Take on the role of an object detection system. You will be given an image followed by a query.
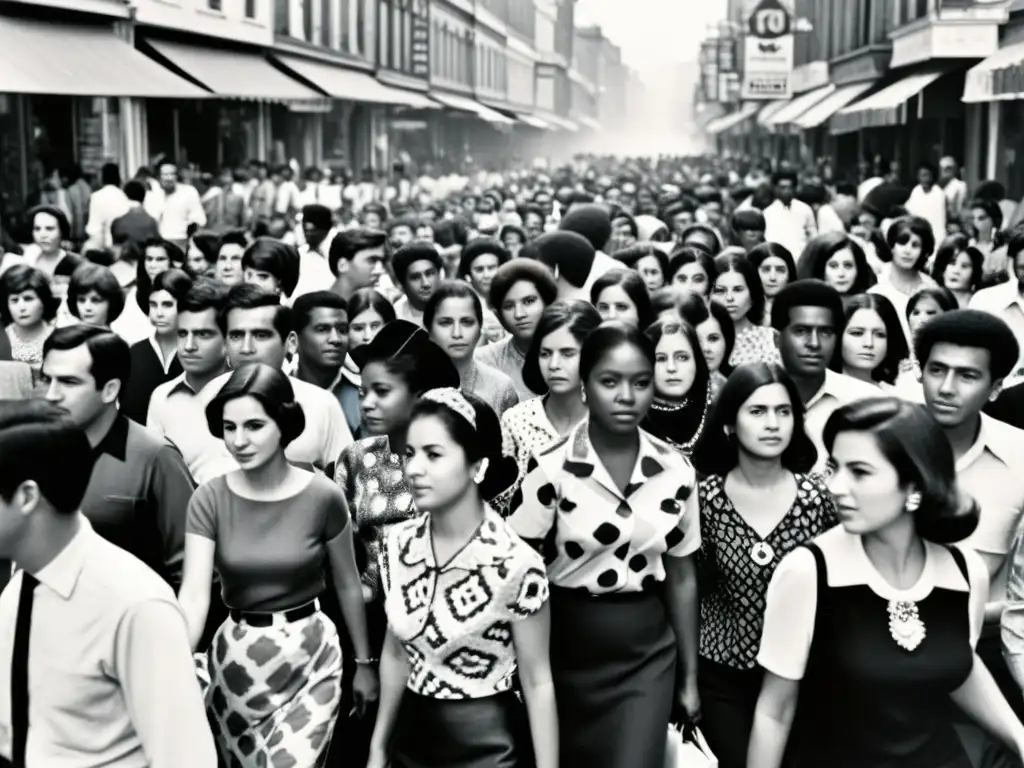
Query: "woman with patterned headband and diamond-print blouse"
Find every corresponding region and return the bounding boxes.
[368,391,558,768]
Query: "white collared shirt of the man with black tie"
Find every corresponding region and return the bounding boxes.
[0,515,217,768]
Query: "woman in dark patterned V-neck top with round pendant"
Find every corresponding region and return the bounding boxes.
[693,362,838,768]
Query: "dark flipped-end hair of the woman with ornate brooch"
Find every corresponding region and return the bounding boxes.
[823,397,979,544]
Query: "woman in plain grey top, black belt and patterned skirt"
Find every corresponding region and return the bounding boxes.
[178,364,379,766]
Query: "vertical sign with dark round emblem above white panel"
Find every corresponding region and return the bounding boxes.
[742,0,794,101]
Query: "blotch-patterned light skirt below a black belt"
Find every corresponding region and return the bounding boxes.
[196,611,341,768]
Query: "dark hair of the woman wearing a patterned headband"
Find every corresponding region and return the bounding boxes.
[409,392,514,502]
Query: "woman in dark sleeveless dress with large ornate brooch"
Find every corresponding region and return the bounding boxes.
[750,397,1024,768]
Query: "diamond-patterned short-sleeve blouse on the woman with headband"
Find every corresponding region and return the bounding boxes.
[380,509,548,699]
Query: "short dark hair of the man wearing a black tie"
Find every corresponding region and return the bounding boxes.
[0,399,93,515]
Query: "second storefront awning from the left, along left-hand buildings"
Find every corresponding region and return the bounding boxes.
[145,38,324,102]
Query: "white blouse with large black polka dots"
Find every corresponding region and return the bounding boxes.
[509,421,700,594]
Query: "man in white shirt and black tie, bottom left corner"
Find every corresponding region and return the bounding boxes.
[0,400,217,768]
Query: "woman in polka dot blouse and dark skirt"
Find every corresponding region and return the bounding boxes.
[509,322,700,768]
